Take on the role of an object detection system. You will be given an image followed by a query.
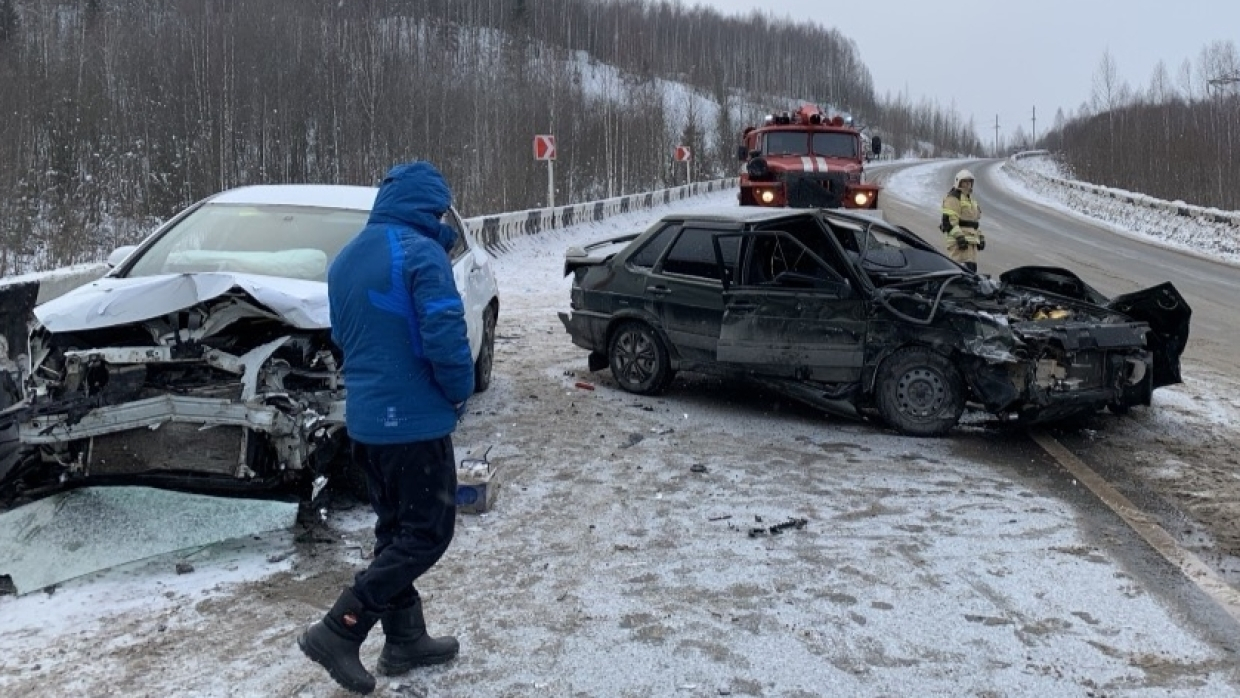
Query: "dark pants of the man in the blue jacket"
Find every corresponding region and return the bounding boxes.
[353,436,456,611]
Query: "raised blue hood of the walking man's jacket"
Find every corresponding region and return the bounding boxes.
[367,160,456,252]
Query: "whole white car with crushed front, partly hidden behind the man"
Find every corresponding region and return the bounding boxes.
[0,185,500,500]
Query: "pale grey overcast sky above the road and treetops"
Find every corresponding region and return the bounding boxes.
[684,0,1240,145]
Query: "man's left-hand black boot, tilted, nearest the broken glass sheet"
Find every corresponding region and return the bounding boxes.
[298,589,379,693]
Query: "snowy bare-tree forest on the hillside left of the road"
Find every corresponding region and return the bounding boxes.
[0,0,981,275]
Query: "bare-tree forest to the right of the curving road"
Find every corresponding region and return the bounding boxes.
[1040,41,1240,211]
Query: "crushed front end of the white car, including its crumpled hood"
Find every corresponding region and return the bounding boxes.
[5,273,347,497]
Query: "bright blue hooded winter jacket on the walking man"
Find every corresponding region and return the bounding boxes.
[327,161,474,444]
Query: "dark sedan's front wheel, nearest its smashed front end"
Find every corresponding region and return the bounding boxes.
[878,347,965,436]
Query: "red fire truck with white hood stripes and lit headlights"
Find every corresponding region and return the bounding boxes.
[737,104,883,212]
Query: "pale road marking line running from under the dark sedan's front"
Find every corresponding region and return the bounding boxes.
[1029,431,1240,622]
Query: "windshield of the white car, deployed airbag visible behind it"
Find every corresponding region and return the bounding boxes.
[125,203,370,281]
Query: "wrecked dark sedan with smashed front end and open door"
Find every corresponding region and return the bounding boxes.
[559,207,1190,436]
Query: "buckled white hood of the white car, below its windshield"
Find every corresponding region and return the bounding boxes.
[35,272,331,332]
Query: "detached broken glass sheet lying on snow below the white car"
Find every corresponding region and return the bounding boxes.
[0,487,298,594]
